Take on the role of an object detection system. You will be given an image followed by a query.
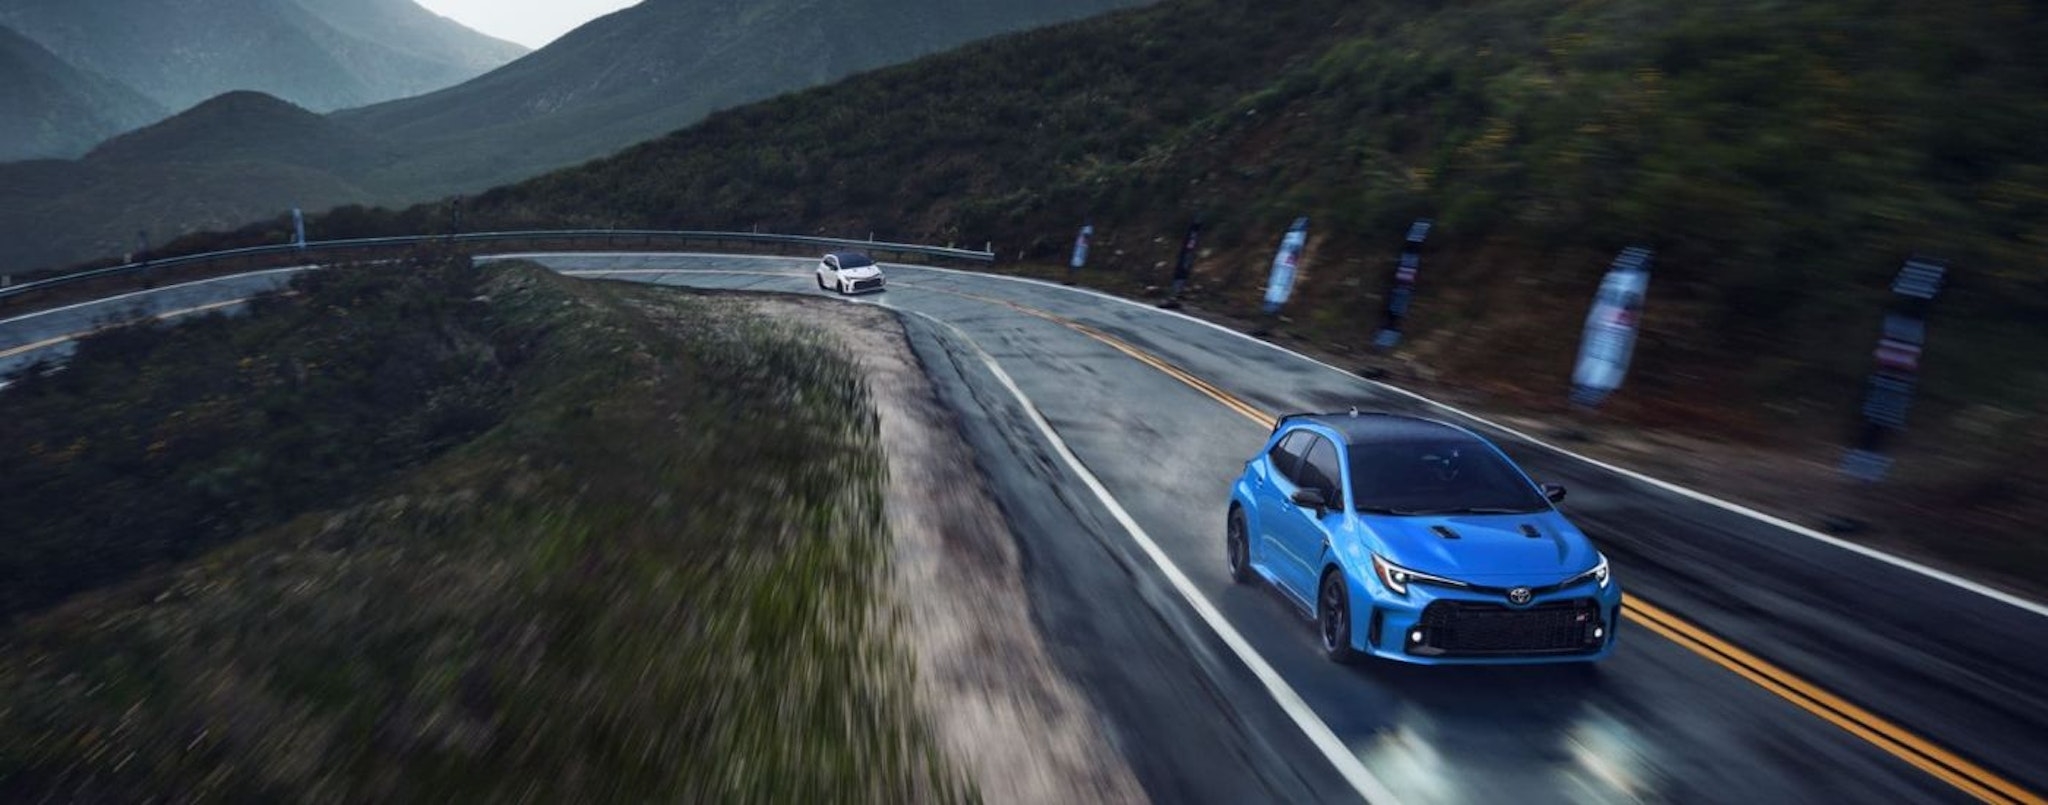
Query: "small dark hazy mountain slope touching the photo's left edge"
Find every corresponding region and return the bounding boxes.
[0,27,164,162]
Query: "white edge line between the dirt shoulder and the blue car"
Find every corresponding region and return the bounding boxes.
[893,307,1401,805]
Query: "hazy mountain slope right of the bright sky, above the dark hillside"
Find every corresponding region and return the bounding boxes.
[336,0,1147,193]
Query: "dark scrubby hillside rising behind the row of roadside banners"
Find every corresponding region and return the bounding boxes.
[448,0,2048,438]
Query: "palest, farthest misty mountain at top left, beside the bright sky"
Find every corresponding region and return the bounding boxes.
[0,0,524,111]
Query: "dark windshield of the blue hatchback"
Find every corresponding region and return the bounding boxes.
[1350,438,1550,514]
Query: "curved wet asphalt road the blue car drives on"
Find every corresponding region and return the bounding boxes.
[0,254,2048,805]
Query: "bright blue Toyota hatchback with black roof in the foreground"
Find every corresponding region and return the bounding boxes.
[1227,412,1622,664]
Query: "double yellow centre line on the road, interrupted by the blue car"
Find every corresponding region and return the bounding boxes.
[966,291,2048,805]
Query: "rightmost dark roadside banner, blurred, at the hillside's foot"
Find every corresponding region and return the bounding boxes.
[1841,256,1948,483]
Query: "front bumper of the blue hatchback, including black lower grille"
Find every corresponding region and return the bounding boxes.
[1352,580,1622,666]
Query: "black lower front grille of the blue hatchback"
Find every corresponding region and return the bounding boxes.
[1407,598,1606,658]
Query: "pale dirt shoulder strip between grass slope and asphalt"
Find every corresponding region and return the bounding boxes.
[752,299,1147,803]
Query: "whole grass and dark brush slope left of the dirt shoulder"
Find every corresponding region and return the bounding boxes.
[0,260,958,803]
